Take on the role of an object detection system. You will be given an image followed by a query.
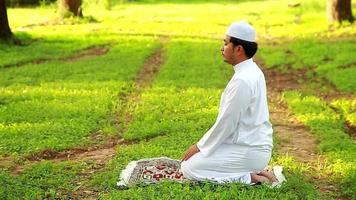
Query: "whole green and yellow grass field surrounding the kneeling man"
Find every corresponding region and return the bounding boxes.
[0,0,356,199]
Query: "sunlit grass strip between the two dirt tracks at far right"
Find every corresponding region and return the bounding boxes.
[283,92,356,199]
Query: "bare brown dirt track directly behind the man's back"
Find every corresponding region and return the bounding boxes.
[256,58,341,199]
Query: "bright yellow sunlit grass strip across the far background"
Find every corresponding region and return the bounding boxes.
[11,0,356,41]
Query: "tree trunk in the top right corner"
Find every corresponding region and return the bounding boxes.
[327,0,355,23]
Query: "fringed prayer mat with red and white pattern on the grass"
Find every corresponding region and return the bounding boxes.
[117,157,186,187]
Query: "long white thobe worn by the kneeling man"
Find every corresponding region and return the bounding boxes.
[181,59,273,184]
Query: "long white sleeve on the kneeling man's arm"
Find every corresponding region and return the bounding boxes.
[197,80,252,157]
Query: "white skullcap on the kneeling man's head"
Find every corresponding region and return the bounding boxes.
[226,21,256,42]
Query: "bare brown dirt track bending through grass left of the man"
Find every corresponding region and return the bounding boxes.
[12,37,168,175]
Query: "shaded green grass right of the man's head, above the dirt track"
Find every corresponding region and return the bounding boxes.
[259,38,356,93]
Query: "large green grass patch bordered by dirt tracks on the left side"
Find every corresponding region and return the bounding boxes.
[0,38,158,157]
